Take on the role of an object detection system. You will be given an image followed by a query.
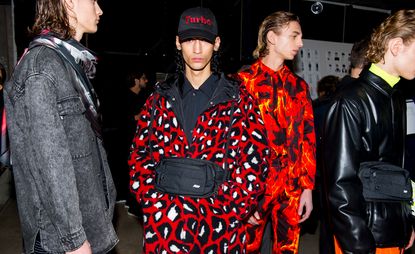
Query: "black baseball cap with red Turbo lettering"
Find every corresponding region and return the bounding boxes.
[177,7,218,44]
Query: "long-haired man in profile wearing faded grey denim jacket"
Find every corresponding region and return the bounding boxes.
[4,0,118,253]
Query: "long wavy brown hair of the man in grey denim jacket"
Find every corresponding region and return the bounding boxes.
[30,0,75,40]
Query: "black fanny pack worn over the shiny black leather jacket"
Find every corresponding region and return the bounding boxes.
[359,161,412,201]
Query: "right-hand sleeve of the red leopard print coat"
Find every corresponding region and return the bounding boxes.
[214,89,269,220]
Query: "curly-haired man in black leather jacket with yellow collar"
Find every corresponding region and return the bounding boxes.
[323,10,415,254]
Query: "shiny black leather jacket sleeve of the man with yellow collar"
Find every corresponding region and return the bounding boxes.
[323,98,375,253]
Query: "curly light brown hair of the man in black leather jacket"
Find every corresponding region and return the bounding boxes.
[366,10,415,63]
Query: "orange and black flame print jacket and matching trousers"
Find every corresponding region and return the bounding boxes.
[238,60,316,253]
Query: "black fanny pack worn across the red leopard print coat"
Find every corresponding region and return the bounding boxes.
[155,158,229,198]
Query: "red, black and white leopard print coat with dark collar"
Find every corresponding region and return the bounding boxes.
[129,75,269,253]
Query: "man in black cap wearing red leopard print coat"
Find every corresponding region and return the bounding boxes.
[129,7,268,253]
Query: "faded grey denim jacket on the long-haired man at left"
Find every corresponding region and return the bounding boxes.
[4,46,118,253]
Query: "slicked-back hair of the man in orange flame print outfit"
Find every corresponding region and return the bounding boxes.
[252,11,300,58]
